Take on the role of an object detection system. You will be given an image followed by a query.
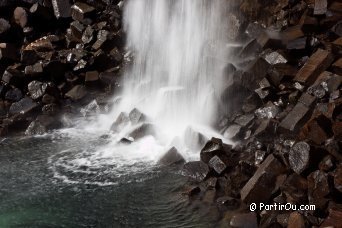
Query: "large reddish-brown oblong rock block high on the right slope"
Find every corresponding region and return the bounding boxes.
[294,49,333,85]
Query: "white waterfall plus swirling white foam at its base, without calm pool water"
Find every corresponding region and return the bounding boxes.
[50,0,229,183]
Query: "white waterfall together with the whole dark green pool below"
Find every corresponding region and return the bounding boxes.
[0,0,229,227]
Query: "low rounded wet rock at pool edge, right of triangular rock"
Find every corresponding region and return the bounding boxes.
[183,161,209,182]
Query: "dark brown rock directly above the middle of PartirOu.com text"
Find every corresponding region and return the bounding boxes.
[280,173,308,204]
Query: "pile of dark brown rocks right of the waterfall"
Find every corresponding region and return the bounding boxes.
[184,0,342,227]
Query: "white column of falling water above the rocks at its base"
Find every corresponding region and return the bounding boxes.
[119,0,228,150]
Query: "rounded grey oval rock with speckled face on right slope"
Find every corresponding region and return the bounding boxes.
[289,142,310,174]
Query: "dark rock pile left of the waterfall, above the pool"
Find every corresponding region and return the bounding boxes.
[0,0,124,136]
